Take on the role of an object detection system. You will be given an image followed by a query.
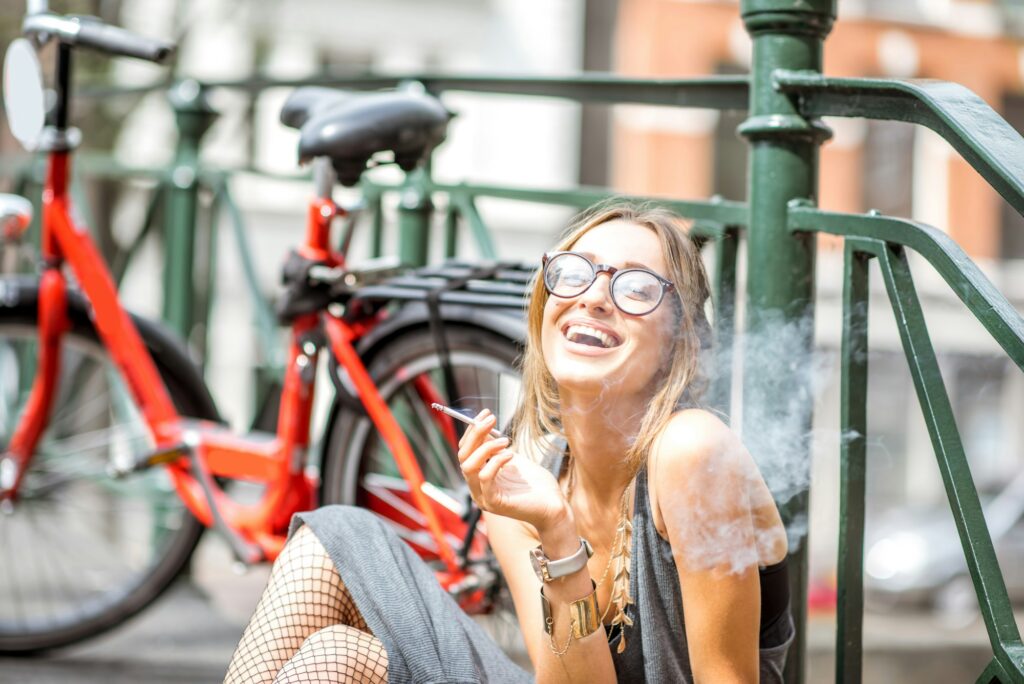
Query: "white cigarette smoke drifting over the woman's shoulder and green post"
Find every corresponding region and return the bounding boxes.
[663,311,843,572]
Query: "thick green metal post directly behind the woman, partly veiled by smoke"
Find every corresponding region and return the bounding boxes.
[739,0,837,682]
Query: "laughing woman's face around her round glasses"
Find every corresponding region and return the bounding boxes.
[541,220,675,397]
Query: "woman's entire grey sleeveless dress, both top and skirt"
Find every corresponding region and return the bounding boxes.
[292,448,795,684]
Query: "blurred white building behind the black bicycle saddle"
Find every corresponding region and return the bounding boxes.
[102,0,585,426]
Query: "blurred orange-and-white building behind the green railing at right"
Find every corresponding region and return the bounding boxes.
[609,0,1024,597]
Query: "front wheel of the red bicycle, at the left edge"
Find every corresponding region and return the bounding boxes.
[0,283,216,653]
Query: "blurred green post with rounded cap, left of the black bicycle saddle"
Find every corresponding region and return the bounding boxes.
[164,80,214,340]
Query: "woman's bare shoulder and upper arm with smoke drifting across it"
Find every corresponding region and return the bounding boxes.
[651,411,785,682]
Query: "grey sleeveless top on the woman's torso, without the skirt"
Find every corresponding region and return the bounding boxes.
[545,452,795,684]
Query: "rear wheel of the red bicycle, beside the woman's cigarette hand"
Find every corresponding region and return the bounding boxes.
[324,325,529,667]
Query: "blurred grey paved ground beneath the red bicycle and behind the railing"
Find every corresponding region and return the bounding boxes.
[0,536,1024,684]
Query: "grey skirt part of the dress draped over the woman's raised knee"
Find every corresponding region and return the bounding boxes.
[291,506,532,684]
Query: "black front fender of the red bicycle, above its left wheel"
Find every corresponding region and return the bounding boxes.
[0,276,221,422]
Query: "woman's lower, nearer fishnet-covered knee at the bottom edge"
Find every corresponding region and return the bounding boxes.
[273,625,387,684]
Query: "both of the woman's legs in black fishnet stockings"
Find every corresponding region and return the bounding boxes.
[224,526,387,684]
